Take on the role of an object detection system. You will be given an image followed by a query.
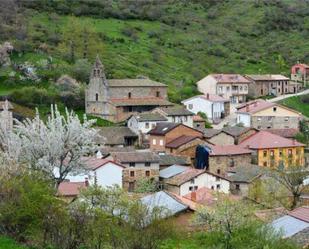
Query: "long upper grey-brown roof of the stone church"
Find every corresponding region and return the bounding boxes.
[107,78,167,87]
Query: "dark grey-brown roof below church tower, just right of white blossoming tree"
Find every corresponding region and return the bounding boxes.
[97,126,138,145]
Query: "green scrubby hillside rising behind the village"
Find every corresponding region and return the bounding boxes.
[0,0,309,101]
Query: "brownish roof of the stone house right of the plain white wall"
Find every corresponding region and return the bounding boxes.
[112,151,160,163]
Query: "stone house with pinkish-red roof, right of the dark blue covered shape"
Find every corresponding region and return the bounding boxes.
[208,145,252,175]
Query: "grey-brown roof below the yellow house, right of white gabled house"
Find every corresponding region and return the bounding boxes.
[226,164,264,183]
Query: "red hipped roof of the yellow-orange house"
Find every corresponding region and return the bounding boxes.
[239,131,305,149]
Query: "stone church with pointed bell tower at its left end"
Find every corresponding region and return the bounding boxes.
[85,58,172,122]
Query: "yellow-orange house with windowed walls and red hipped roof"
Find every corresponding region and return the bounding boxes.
[240,131,305,168]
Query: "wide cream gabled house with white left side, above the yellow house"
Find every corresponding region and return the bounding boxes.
[236,99,302,130]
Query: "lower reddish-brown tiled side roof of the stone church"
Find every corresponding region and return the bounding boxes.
[110,97,173,106]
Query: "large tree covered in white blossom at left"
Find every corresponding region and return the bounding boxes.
[0,106,97,186]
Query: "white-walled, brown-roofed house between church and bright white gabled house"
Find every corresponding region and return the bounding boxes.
[152,106,194,127]
